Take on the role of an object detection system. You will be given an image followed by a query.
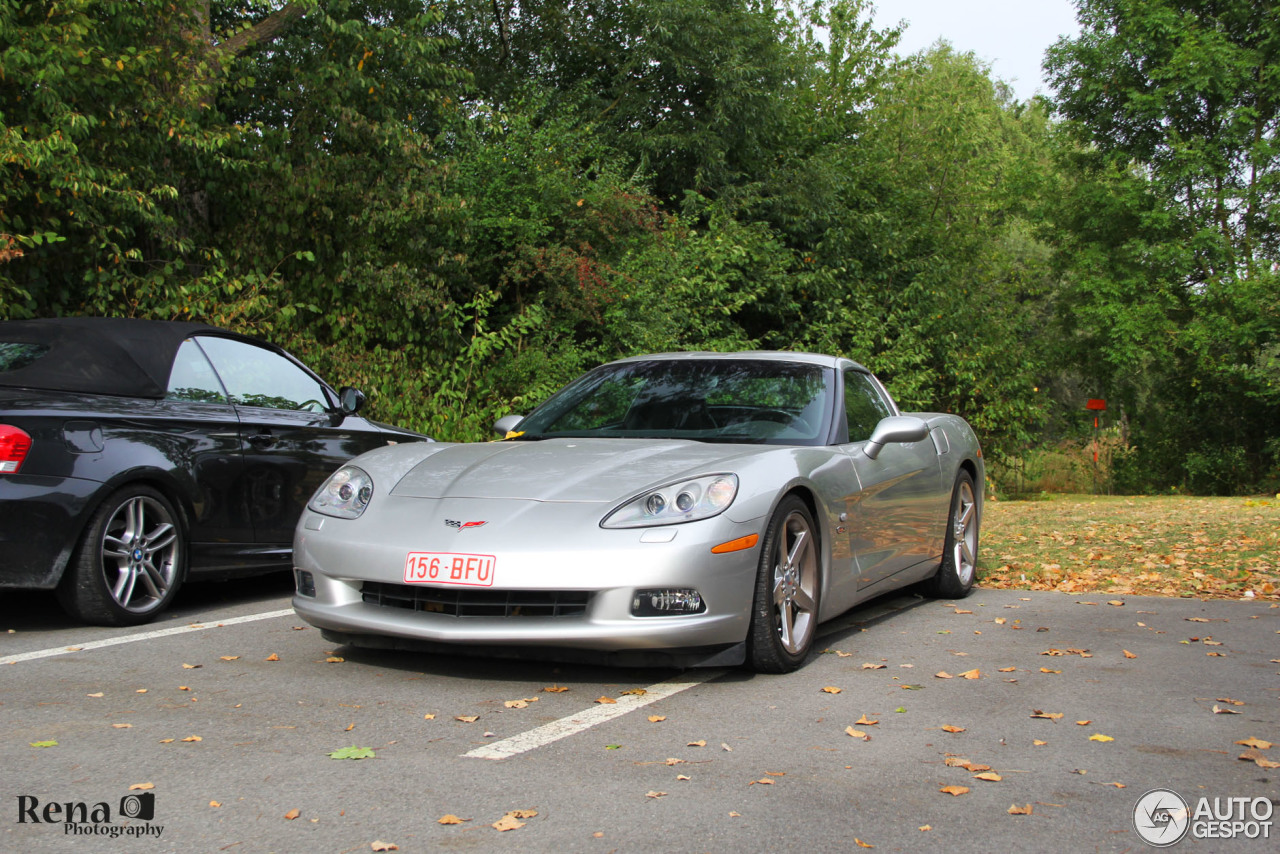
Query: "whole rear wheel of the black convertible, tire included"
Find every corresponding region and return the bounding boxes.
[58,485,187,626]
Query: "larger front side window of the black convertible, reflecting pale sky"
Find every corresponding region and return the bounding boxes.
[200,335,329,412]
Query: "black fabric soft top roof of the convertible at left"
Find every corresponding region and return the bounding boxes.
[0,318,264,399]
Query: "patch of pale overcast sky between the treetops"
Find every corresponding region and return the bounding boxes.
[874,0,1079,101]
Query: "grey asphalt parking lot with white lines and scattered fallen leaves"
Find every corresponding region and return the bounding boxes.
[0,580,1280,854]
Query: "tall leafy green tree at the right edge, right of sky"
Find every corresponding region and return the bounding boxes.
[1046,0,1280,492]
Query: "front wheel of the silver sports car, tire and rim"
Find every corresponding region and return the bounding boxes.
[746,495,822,673]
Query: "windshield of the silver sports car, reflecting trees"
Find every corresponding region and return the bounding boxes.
[518,359,835,446]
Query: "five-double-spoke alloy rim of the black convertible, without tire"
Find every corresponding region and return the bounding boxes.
[101,495,179,613]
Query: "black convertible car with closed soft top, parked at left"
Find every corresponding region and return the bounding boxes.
[0,318,426,626]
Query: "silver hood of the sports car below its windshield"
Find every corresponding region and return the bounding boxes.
[392,439,765,502]
